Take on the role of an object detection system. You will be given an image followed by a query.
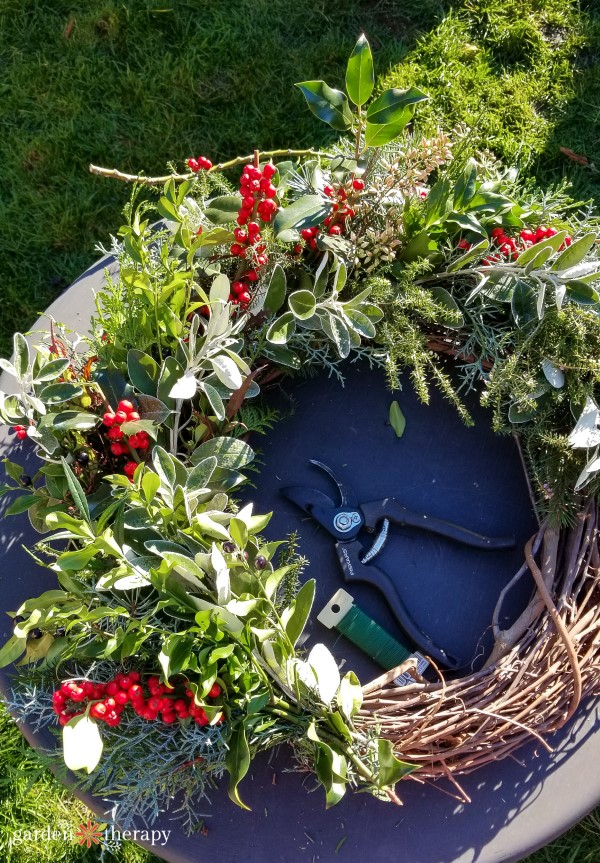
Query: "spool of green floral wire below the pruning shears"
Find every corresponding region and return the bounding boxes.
[317,589,429,684]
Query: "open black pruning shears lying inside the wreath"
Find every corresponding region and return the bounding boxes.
[280,459,515,669]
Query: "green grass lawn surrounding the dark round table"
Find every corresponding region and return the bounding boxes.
[0,0,600,863]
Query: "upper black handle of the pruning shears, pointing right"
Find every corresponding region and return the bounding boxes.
[361,497,515,551]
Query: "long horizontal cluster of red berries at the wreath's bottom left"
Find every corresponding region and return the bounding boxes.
[52,671,225,727]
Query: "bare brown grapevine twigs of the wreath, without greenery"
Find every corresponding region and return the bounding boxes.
[359,503,600,799]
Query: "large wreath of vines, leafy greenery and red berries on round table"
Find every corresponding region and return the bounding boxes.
[0,37,600,823]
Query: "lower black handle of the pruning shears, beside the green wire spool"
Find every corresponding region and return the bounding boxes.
[335,541,464,670]
